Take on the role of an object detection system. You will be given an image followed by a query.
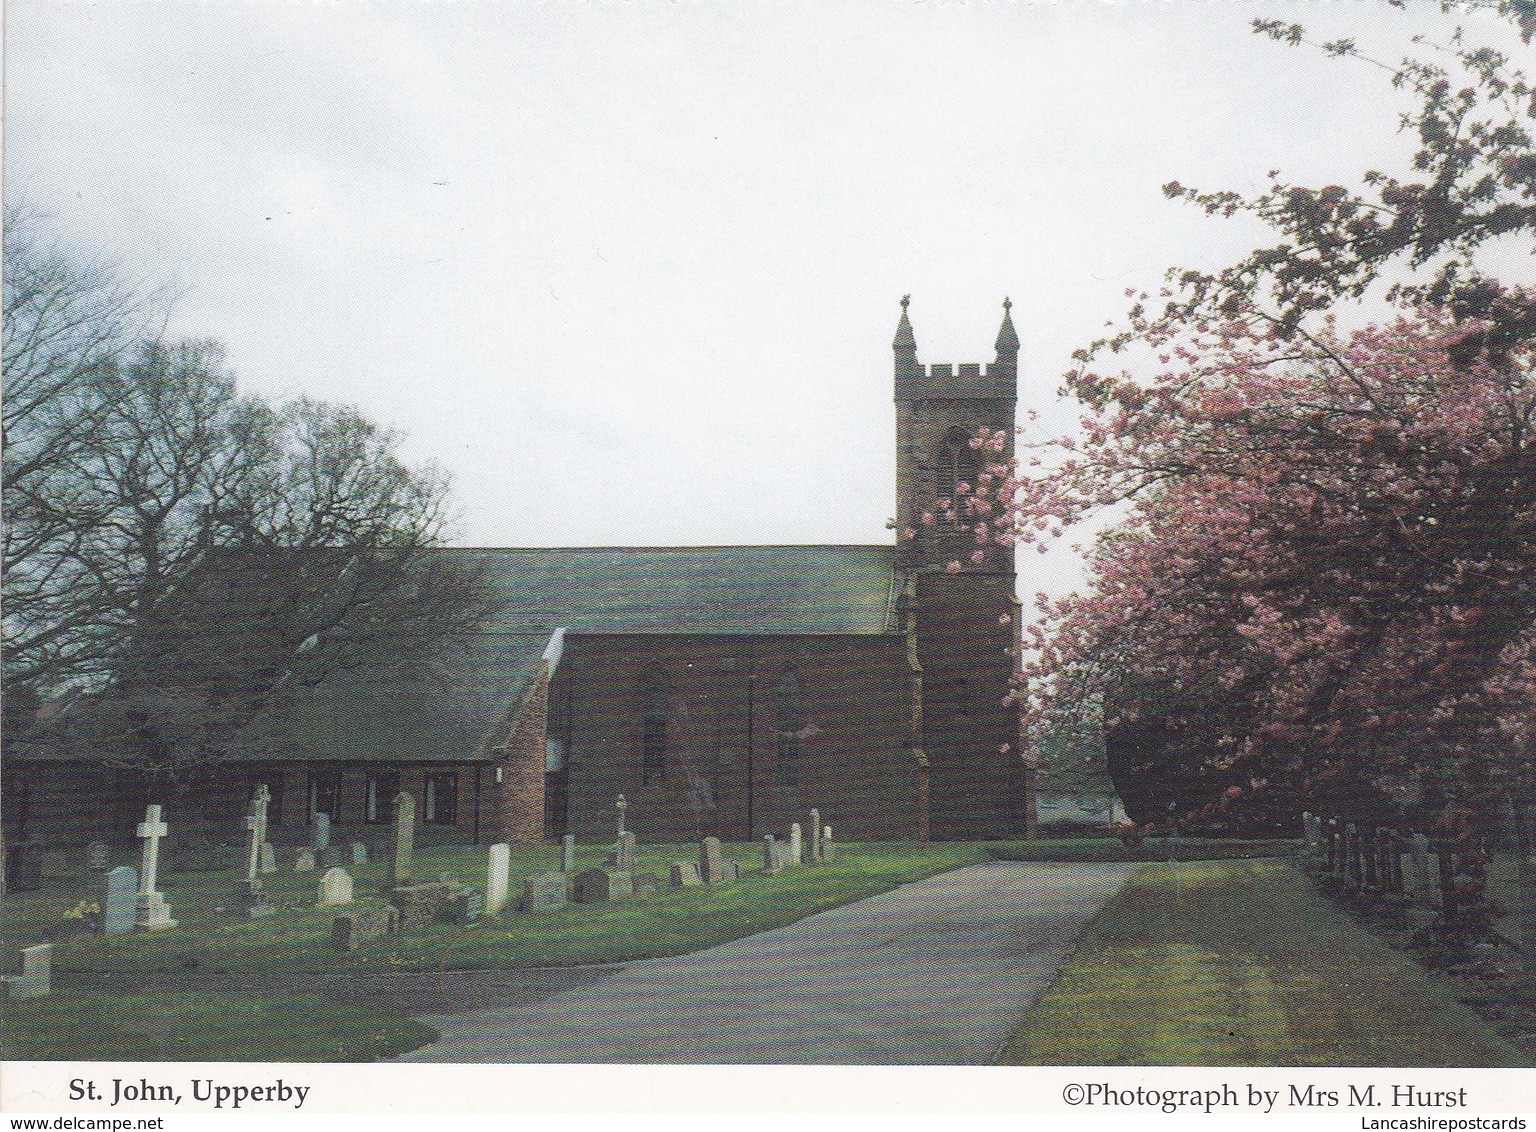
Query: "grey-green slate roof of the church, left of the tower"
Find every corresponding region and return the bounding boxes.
[287,547,897,763]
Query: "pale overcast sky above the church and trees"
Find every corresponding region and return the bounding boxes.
[5,0,1486,593]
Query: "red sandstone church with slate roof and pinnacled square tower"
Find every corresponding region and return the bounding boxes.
[6,298,1032,843]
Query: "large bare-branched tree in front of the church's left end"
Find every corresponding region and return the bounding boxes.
[5,213,490,774]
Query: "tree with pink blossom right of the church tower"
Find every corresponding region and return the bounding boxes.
[935,3,1536,927]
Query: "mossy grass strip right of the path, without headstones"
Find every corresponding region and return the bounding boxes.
[1000,860,1536,1066]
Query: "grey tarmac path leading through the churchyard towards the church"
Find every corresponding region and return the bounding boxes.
[396,862,1137,1064]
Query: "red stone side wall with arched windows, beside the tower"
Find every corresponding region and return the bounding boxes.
[551,634,919,843]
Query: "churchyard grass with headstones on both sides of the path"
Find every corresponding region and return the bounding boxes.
[0,791,1536,1066]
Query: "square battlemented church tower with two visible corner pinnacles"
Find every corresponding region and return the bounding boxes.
[892,298,1029,840]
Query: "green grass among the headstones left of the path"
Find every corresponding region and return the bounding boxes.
[0,843,988,1061]
